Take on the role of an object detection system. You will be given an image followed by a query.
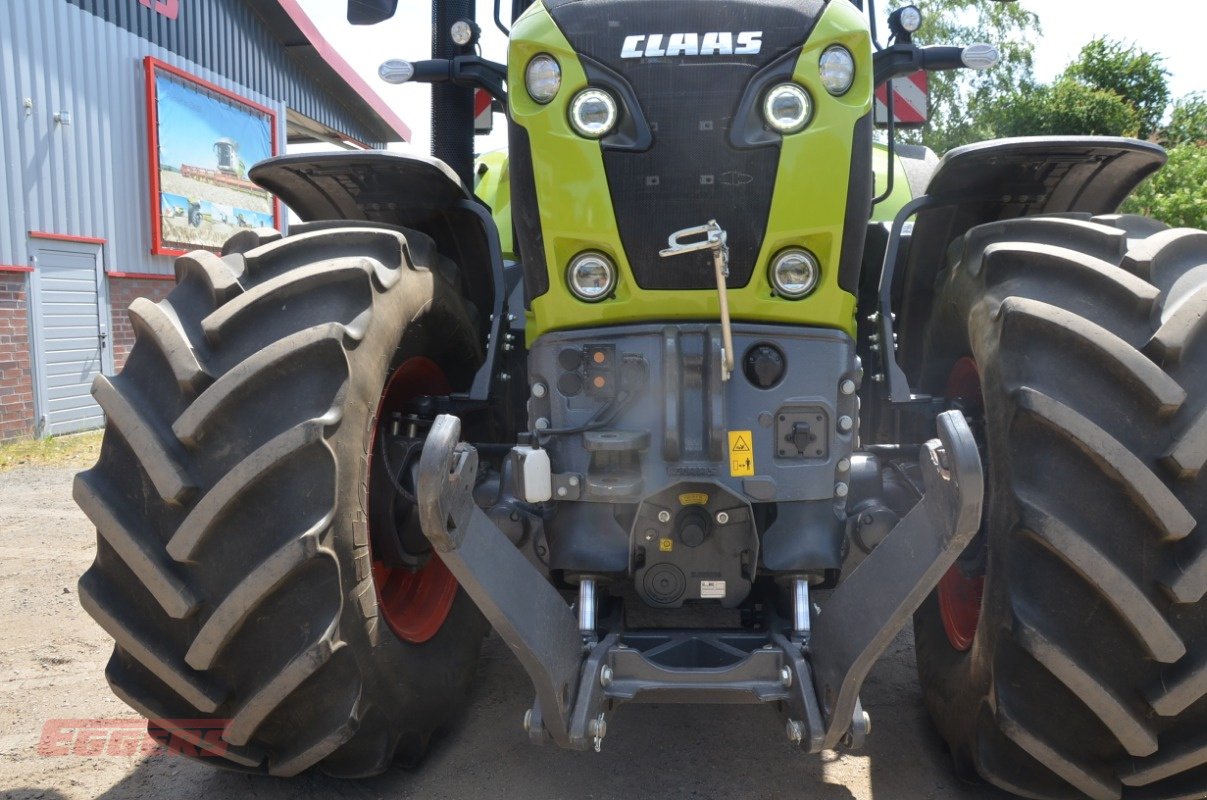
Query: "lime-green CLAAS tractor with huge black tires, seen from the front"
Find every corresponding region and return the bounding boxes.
[75,0,1207,800]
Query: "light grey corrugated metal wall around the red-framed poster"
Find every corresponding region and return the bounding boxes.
[0,0,285,274]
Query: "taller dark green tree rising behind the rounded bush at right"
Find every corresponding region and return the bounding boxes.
[1065,39,1170,139]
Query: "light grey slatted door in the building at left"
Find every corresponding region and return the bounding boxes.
[31,241,112,434]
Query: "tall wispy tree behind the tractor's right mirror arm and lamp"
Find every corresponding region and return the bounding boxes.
[897,0,1040,153]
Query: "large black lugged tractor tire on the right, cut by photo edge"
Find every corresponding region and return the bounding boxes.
[915,216,1207,800]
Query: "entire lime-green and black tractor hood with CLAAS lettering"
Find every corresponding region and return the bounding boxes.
[507,0,873,339]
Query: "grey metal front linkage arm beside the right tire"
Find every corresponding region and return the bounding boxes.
[809,411,985,749]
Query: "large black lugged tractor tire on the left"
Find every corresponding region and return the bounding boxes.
[75,227,486,777]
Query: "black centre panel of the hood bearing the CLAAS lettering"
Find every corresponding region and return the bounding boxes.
[546,0,826,290]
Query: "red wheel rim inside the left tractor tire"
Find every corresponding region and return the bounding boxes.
[369,356,457,644]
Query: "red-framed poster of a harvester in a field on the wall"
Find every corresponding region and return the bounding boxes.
[147,59,279,255]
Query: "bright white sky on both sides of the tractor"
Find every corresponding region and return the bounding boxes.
[294,0,1207,155]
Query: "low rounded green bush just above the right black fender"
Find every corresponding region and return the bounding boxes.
[979,77,1142,136]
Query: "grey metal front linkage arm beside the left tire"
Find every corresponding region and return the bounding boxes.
[415,414,583,747]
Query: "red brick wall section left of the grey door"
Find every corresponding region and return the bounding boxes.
[0,273,34,442]
